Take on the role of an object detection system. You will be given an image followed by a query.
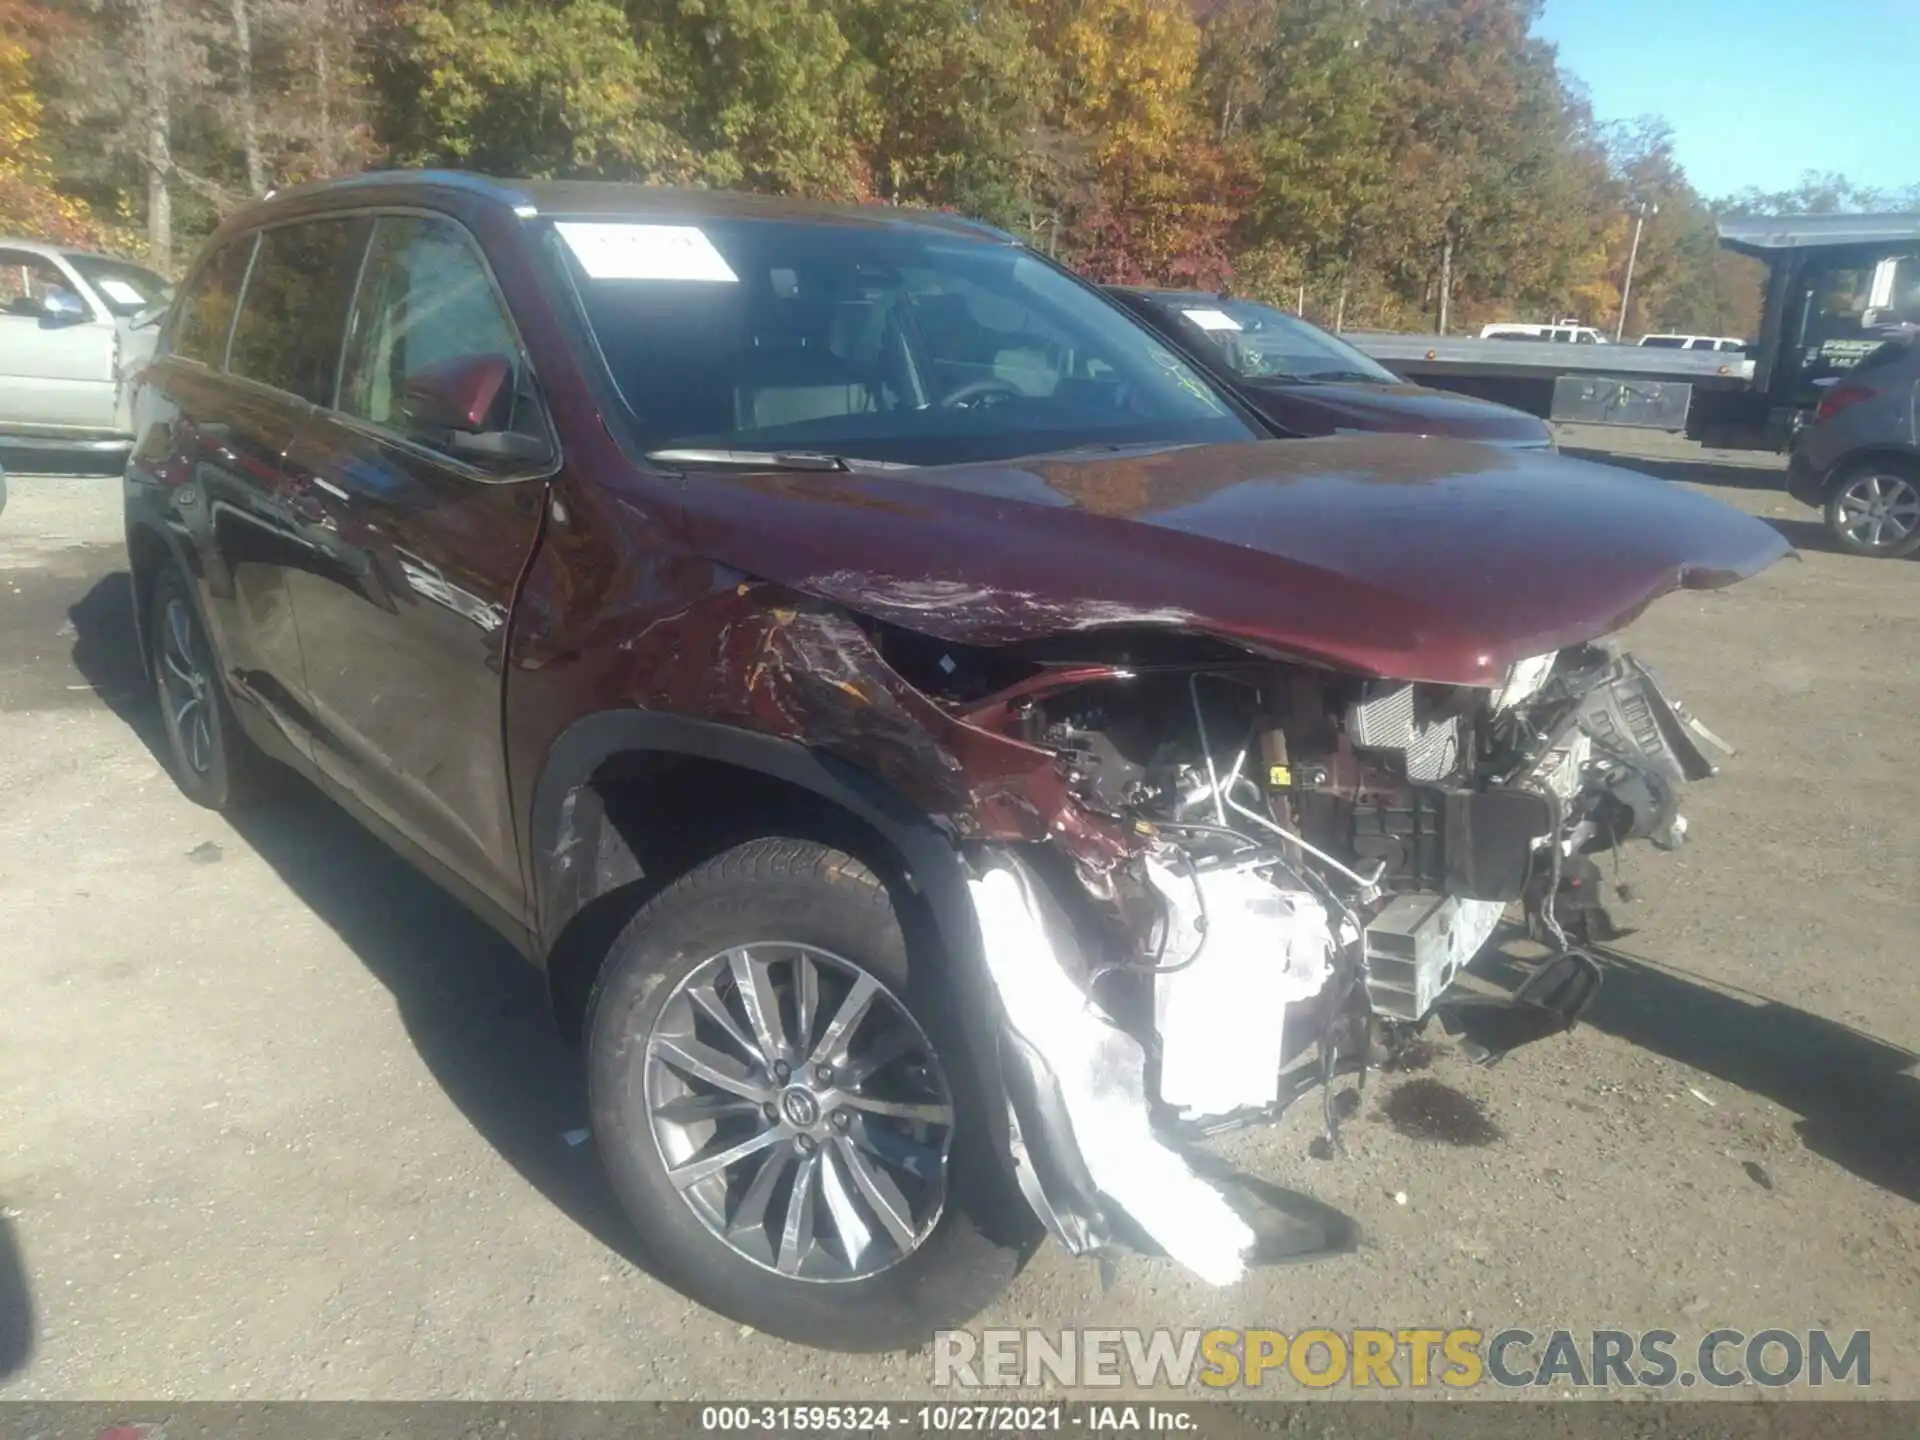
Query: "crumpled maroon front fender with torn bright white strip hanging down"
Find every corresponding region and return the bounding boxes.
[622,576,1352,1283]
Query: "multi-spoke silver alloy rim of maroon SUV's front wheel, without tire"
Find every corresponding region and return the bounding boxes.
[645,943,954,1283]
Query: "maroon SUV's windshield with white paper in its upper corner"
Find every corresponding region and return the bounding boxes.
[551,219,1254,465]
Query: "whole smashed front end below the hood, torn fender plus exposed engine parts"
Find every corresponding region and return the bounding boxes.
[622,576,1743,1283]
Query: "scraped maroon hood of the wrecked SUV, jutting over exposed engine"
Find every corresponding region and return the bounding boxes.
[684,436,1791,685]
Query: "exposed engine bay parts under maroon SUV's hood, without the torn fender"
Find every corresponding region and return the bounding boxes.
[1008,645,1718,1117]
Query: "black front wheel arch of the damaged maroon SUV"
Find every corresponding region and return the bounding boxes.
[528,710,979,1039]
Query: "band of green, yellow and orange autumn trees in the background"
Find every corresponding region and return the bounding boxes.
[0,0,1912,332]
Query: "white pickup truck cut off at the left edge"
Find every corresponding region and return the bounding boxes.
[0,238,173,453]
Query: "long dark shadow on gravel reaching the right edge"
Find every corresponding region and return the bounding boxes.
[1486,947,1920,1204]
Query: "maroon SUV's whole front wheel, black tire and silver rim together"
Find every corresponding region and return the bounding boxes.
[588,839,1033,1352]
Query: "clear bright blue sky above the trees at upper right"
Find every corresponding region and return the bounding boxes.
[1536,0,1920,198]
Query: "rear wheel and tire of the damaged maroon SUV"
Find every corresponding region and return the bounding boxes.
[146,564,273,810]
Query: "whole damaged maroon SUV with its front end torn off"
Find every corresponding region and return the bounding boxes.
[127,173,1786,1350]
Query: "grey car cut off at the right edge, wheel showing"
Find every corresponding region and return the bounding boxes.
[1788,338,1920,557]
